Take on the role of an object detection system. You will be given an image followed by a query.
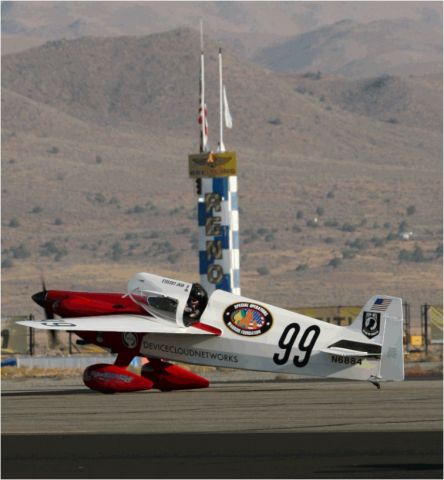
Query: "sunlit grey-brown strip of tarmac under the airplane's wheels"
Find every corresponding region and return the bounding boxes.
[2,374,442,434]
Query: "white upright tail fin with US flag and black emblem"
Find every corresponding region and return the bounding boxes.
[347,295,404,382]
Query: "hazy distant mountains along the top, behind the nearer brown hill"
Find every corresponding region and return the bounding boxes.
[2,1,442,77]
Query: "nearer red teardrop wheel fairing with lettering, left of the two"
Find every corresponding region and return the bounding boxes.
[83,363,153,393]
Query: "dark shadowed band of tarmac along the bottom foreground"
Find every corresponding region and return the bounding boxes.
[1,431,443,479]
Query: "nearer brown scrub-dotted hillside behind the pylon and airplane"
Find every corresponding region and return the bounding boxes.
[2,29,442,315]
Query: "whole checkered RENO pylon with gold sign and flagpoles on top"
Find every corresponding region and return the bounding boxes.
[188,27,240,295]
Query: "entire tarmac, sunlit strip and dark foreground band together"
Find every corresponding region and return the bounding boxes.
[2,379,443,478]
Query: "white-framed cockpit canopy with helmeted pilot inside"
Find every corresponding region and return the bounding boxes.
[128,273,208,326]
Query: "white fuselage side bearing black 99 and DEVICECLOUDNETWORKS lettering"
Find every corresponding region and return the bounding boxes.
[140,290,378,379]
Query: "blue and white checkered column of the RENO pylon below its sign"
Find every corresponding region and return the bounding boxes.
[198,176,240,295]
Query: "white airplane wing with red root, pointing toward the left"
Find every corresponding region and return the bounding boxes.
[17,315,221,335]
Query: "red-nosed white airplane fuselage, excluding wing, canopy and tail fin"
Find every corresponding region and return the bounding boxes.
[32,284,377,379]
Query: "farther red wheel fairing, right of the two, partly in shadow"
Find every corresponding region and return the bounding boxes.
[141,359,210,391]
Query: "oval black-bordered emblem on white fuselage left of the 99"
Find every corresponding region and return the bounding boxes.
[223,302,273,337]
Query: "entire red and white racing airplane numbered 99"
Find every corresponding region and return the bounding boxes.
[17,272,404,393]
